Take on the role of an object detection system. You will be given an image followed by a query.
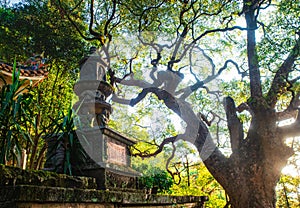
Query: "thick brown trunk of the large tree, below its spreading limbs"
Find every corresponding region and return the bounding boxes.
[196,109,292,208]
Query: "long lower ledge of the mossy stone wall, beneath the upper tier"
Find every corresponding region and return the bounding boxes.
[0,185,202,205]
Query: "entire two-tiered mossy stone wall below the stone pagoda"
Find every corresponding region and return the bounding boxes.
[0,165,204,208]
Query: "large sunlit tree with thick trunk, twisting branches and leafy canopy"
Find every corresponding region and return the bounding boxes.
[56,0,300,208]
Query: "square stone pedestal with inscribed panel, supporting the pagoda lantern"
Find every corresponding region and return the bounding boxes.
[74,127,141,190]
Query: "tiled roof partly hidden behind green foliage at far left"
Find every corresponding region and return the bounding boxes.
[0,62,49,79]
